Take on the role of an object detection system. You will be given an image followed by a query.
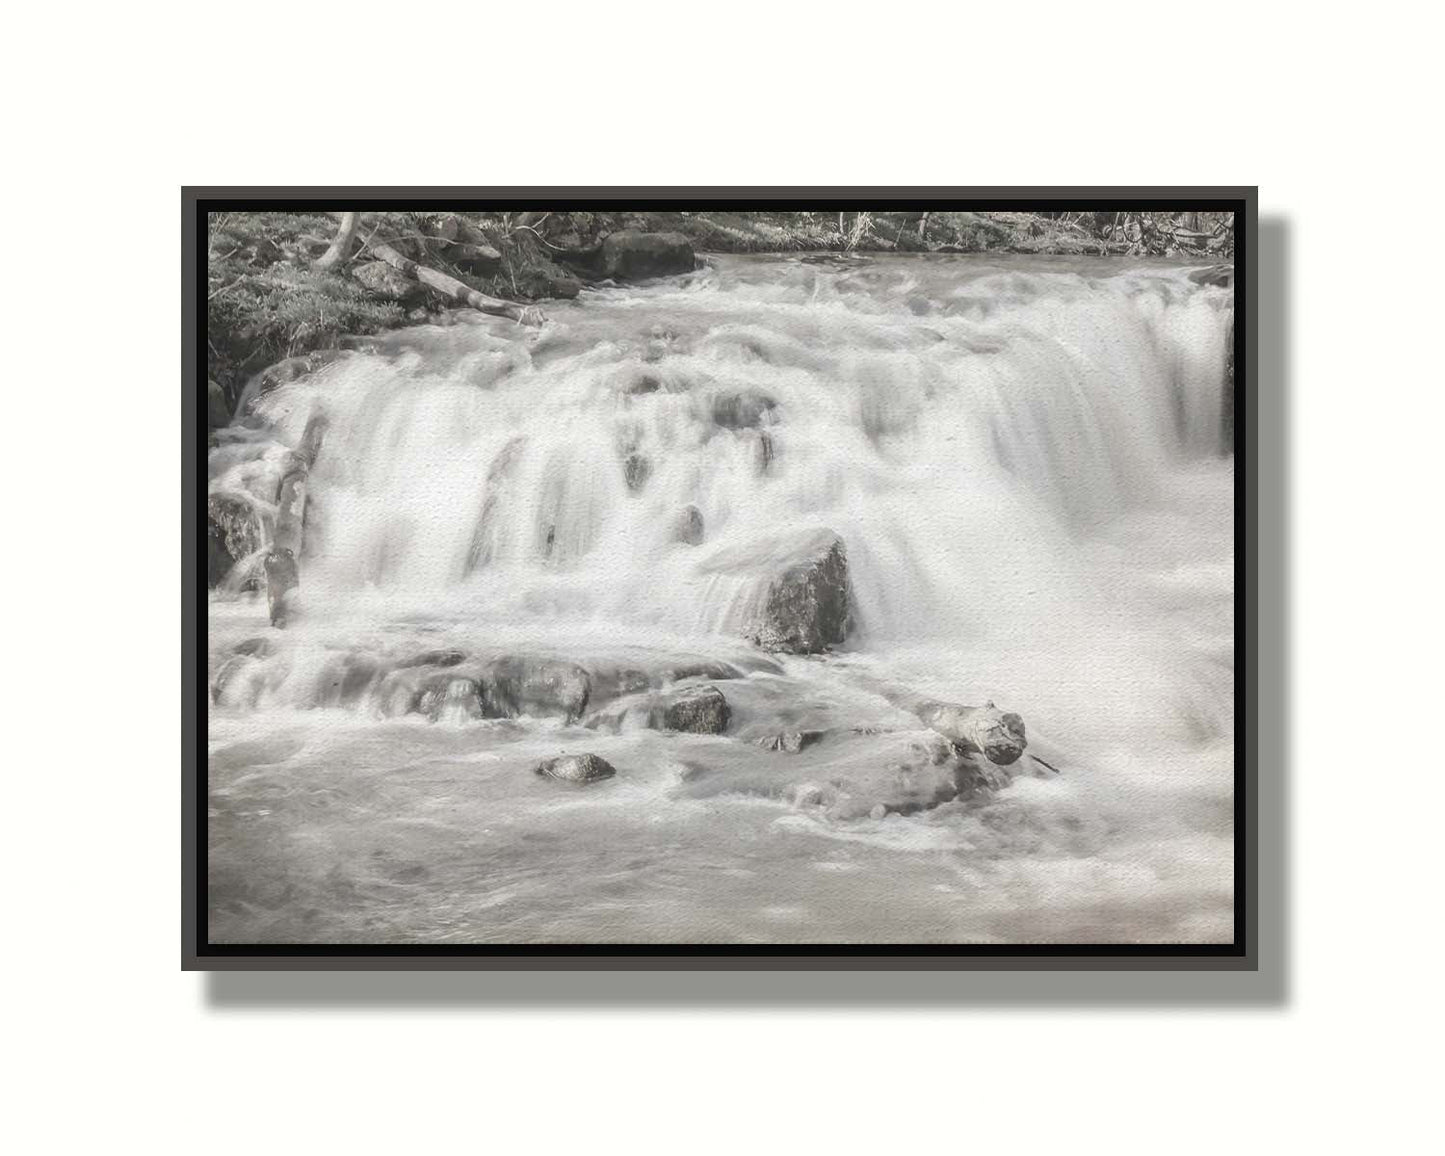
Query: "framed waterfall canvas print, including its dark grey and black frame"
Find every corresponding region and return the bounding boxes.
[182,188,1256,970]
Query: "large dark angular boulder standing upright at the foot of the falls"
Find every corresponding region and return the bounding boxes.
[744,532,853,655]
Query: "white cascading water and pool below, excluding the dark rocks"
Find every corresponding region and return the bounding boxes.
[210,257,1234,942]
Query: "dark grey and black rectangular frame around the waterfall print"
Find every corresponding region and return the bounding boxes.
[181,186,1260,971]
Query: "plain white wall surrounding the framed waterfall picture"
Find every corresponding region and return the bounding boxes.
[0,3,1445,1155]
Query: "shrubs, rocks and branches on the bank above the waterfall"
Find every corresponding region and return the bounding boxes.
[207,210,1234,409]
